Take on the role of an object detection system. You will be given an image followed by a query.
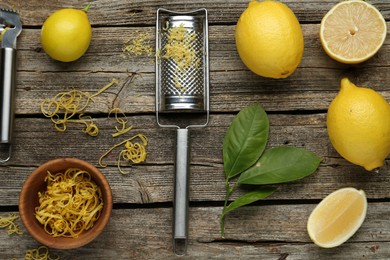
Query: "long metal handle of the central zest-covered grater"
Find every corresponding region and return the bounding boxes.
[173,128,190,255]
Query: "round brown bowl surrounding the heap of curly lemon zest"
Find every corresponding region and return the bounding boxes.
[19,158,112,249]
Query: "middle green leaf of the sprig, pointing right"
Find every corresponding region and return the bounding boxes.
[238,146,321,184]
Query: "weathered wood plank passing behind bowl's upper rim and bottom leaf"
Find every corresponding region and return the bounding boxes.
[0,159,390,206]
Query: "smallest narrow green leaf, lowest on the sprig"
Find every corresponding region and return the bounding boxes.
[221,186,277,218]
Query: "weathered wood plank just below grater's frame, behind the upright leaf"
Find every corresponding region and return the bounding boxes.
[4,114,337,166]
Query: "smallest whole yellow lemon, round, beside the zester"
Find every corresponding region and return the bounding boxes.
[41,8,92,62]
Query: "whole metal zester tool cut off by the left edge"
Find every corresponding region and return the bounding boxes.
[0,9,22,163]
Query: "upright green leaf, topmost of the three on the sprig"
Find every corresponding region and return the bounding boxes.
[223,104,269,179]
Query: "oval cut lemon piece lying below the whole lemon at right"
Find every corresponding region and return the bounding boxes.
[307,187,367,248]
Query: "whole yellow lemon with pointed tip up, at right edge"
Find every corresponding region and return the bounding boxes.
[327,78,390,171]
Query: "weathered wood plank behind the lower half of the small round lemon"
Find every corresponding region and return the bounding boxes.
[18,24,390,71]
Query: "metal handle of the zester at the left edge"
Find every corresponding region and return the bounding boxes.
[0,47,16,163]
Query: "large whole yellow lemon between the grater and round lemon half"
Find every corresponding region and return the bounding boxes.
[236,1,304,79]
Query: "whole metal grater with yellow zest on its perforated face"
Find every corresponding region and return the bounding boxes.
[156,8,209,255]
